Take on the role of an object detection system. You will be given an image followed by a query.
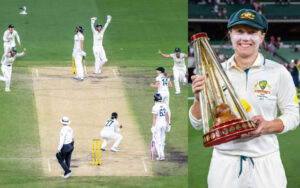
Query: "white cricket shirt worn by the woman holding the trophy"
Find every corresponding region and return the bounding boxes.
[189,53,299,157]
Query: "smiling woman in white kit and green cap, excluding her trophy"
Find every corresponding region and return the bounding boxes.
[189,9,299,188]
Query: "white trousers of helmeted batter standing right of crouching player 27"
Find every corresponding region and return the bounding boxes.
[154,125,167,157]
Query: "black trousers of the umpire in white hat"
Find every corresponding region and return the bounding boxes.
[58,142,74,174]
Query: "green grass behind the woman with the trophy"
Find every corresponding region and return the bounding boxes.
[188,86,300,188]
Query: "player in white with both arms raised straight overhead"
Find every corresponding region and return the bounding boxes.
[91,15,111,74]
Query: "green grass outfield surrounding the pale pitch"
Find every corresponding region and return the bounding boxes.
[0,0,187,188]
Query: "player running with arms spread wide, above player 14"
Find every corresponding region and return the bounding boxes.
[158,48,188,94]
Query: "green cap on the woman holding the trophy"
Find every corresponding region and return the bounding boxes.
[227,9,268,33]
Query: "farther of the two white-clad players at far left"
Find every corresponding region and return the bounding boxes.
[3,24,21,54]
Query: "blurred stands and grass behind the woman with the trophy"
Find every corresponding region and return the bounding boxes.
[188,0,300,188]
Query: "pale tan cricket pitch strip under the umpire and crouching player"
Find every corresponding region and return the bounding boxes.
[32,67,153,176]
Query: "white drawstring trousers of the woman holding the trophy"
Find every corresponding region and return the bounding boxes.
[207,149,287,188]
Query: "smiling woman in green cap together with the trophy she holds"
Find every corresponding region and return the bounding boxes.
[189,9,299,188]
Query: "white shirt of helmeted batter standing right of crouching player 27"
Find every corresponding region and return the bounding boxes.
[152,102,168,126]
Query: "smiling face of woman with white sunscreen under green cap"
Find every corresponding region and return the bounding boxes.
[228,25,265,58]
